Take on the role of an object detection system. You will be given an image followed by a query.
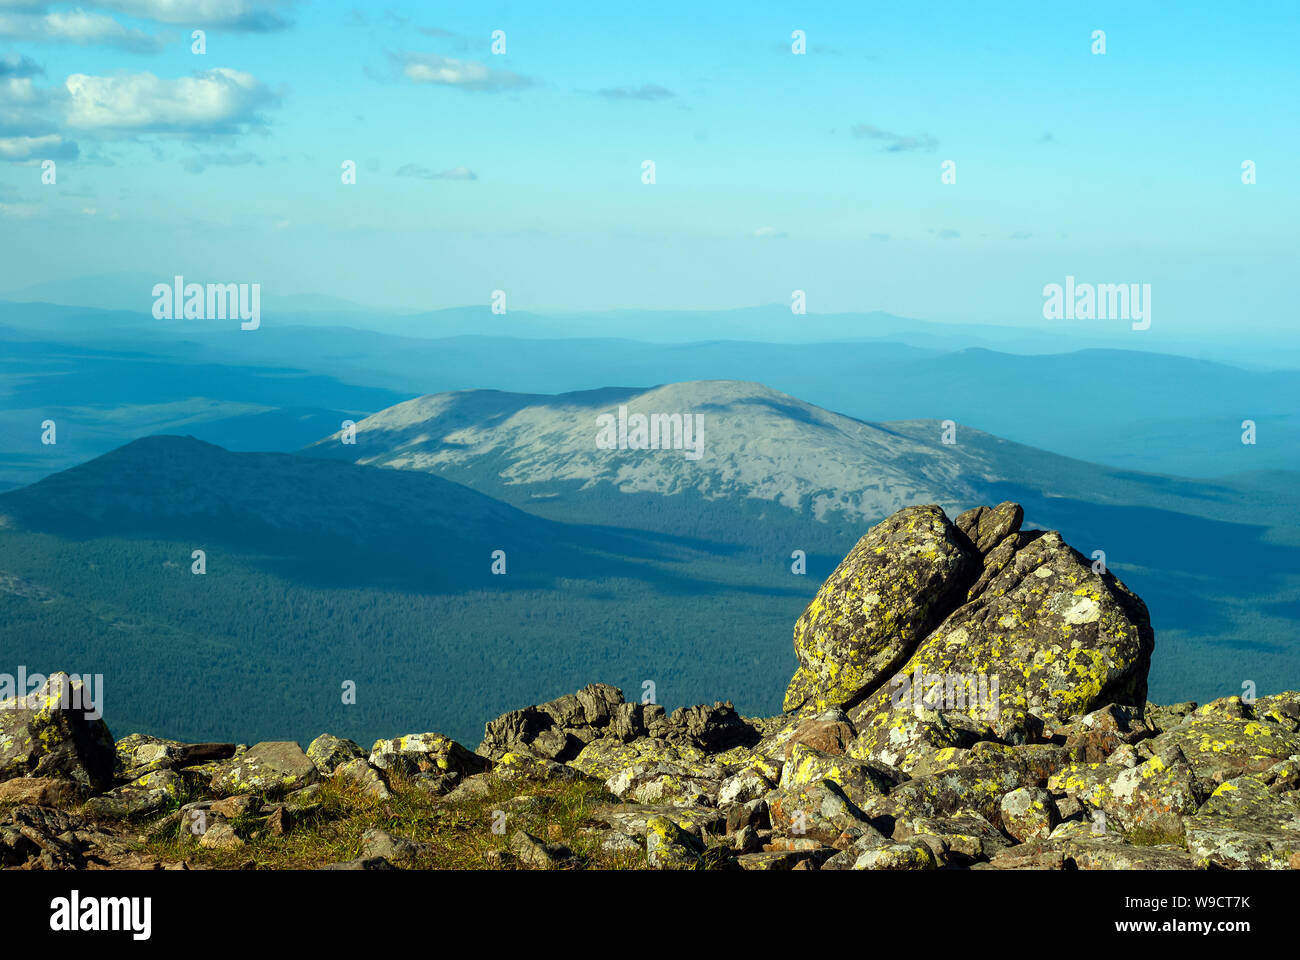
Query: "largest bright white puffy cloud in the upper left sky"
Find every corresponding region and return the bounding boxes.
[65,68,276,135]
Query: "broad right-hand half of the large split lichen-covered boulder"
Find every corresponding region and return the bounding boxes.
[849,532,1154,758]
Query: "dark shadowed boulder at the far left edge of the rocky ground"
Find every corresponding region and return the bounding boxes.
[0,673,117,790]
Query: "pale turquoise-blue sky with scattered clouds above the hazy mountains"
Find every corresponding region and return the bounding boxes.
[0,0,1300,338]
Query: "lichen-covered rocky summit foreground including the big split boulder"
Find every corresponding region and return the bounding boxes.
[0,503,1300,870]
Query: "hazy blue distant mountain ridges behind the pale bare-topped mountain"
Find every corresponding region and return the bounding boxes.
[0,304,1300,489]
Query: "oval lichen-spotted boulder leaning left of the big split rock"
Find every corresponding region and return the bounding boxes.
[784,505,979,713]
